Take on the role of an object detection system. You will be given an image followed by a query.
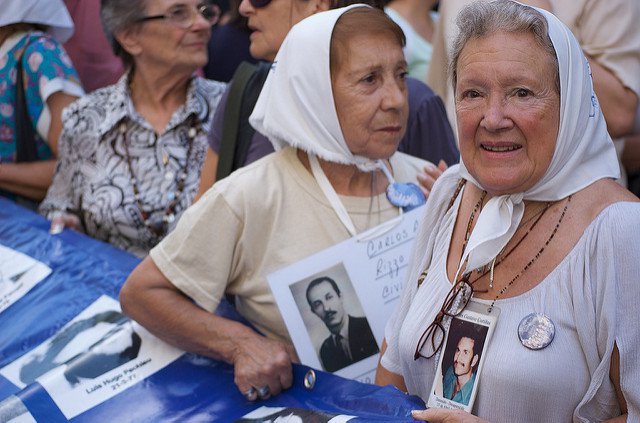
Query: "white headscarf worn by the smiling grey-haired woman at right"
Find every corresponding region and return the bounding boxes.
[460,5,620,269]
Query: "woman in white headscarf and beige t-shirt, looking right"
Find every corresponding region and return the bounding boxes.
[120,5,425,400]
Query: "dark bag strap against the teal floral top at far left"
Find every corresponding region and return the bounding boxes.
[16,39,38,163]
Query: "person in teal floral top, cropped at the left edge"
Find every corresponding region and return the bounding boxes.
[0,0,83,201]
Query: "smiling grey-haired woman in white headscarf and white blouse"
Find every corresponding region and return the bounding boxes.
[376,0,640,422]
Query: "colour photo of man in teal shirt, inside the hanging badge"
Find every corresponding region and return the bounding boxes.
[441,318,489,406]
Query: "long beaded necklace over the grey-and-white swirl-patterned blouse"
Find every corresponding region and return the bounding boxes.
[119,116,198,237]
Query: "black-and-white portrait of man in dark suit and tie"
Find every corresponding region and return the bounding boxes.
[290,263,380,372]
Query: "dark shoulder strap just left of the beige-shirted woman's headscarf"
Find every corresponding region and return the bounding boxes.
[216,62,256,181]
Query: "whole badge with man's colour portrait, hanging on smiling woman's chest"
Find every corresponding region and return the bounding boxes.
[427,300,500,412]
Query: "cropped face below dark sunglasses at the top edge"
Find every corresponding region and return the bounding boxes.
[238,0,316,61]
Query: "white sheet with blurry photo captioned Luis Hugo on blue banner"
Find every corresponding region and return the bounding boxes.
[0,295,183,419]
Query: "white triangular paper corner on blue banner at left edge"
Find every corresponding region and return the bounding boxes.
[0,244,51,313]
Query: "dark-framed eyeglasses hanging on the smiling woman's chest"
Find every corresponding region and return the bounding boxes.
[413,274,473,360]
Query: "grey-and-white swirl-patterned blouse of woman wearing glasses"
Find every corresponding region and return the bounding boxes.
[40,75,226,257]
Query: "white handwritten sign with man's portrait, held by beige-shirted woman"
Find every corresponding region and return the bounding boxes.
[267,208,422,383]
